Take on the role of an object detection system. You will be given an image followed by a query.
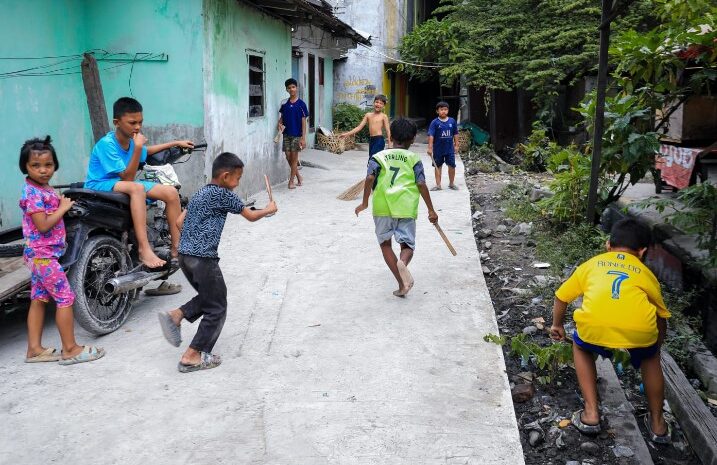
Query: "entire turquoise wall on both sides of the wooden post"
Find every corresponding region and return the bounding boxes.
[0,0,204,229]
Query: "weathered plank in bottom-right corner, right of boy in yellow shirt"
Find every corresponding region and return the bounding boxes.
[662,351,717,465]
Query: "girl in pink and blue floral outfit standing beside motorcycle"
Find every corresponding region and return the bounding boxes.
[20,136,105,365]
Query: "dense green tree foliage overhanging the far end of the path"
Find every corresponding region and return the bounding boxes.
[400,0,651,108]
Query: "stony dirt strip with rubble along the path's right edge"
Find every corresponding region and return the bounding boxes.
[464,159,699,465]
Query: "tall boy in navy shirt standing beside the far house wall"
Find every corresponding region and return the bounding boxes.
[278,79,309,189]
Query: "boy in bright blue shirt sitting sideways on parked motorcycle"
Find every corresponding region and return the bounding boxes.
[85,97,194,268]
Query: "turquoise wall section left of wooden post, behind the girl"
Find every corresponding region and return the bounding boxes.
[0,0,92,229]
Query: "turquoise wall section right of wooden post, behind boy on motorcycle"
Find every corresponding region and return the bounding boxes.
[86,0,204,127]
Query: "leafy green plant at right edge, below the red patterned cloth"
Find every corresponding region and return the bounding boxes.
[638,183,717,268]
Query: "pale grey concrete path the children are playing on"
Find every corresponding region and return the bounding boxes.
[0,146,524,465]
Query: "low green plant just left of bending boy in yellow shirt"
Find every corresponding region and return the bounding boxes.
[483,334,573,384]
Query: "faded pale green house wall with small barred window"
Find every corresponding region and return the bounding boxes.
[204,0,291,196]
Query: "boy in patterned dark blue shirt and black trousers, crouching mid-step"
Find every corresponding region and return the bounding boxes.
[158,152,276,373]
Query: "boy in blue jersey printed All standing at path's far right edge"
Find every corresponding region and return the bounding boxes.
[428,102,458,191]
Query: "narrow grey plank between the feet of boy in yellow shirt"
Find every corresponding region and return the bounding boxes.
[595,357,654,465]
